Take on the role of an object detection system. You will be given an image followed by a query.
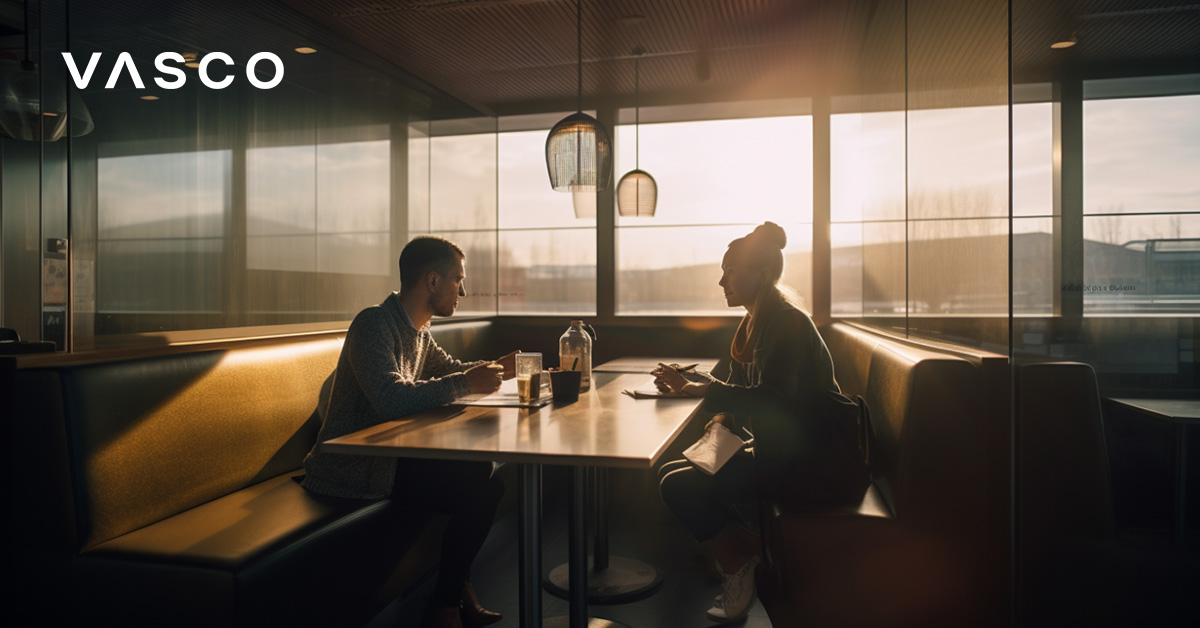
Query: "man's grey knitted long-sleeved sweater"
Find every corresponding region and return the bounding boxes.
[304,293,482,500]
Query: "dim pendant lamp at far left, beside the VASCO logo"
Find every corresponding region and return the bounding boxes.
[0,7,96,142]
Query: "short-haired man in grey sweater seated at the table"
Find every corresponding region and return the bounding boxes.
[304,237,516,628]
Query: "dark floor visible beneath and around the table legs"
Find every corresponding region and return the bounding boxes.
[368,472,770,628]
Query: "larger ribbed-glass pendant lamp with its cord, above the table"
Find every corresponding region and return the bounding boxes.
[546,0,612,192]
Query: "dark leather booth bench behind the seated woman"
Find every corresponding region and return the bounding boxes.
[757,324,1007,628]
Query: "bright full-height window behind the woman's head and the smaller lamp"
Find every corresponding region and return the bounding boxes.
[613,112,812,315]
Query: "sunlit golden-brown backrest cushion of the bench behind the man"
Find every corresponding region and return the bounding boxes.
[59,336,342,548]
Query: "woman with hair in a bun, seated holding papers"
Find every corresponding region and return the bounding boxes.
[654,222,869,622]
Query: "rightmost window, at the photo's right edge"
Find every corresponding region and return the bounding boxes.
[1084,84,1200,315]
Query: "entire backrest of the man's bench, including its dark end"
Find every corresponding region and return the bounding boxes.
[4,322,490,555]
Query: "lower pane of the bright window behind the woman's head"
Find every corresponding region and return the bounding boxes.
[617,223,812,316]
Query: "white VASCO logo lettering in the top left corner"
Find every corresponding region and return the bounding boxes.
[62,53,283,89]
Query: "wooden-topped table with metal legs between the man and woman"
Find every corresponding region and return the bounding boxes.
[322,372,700,628]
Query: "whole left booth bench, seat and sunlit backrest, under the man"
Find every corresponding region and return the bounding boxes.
[4,323,488,627]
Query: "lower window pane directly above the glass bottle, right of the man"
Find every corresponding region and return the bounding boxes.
[499,228,596,316]
